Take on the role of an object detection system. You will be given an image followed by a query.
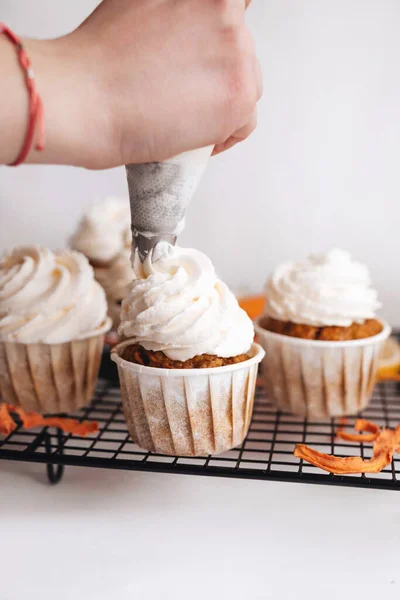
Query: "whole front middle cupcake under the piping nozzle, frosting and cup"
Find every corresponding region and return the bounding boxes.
[112,242,264,456]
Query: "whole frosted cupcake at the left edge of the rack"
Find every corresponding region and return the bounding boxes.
[0,247,111,414]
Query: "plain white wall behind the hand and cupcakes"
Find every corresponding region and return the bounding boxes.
[0,0,400,324]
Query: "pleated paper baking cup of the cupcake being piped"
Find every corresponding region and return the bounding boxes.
[111,340,265,456]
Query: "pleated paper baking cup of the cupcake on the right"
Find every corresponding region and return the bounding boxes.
[255,319,391,419]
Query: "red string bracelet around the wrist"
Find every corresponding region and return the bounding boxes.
[0,23,44,167]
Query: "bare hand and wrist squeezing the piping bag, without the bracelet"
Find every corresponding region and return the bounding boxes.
[1,0,262,169]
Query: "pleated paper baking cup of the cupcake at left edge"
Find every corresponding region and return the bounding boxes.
[0,319,111,414]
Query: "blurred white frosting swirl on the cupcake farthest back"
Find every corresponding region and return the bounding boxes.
[70,198,132,263]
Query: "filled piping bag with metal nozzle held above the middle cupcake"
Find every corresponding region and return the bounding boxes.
[126,146,213,262]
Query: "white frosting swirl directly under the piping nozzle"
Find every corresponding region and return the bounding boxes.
[119,242,254,361]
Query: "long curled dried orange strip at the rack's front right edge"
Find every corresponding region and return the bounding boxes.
[294,429,400,475]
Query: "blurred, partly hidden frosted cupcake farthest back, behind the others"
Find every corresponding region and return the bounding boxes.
[70,198,132,328]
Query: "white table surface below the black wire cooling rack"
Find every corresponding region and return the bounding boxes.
[0,461,400,600]
